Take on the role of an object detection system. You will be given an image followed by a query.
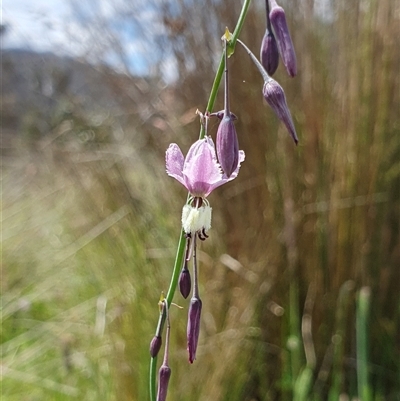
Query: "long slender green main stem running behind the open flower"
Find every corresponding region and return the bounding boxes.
[149,0,251,401]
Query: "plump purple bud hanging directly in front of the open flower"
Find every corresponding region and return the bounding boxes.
[216,113,239,177]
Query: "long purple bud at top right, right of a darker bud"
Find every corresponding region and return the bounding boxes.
[269,0,297,77]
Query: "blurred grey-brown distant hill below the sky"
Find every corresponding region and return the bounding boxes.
[1,50,170,151]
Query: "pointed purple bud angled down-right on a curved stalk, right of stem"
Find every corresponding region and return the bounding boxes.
[263,78,299,145]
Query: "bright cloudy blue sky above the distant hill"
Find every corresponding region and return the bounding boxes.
[1,0,178,81]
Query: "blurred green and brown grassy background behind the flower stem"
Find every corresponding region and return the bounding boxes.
[1,0,400,401]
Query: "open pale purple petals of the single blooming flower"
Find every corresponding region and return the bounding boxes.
[165,136,245,198]
